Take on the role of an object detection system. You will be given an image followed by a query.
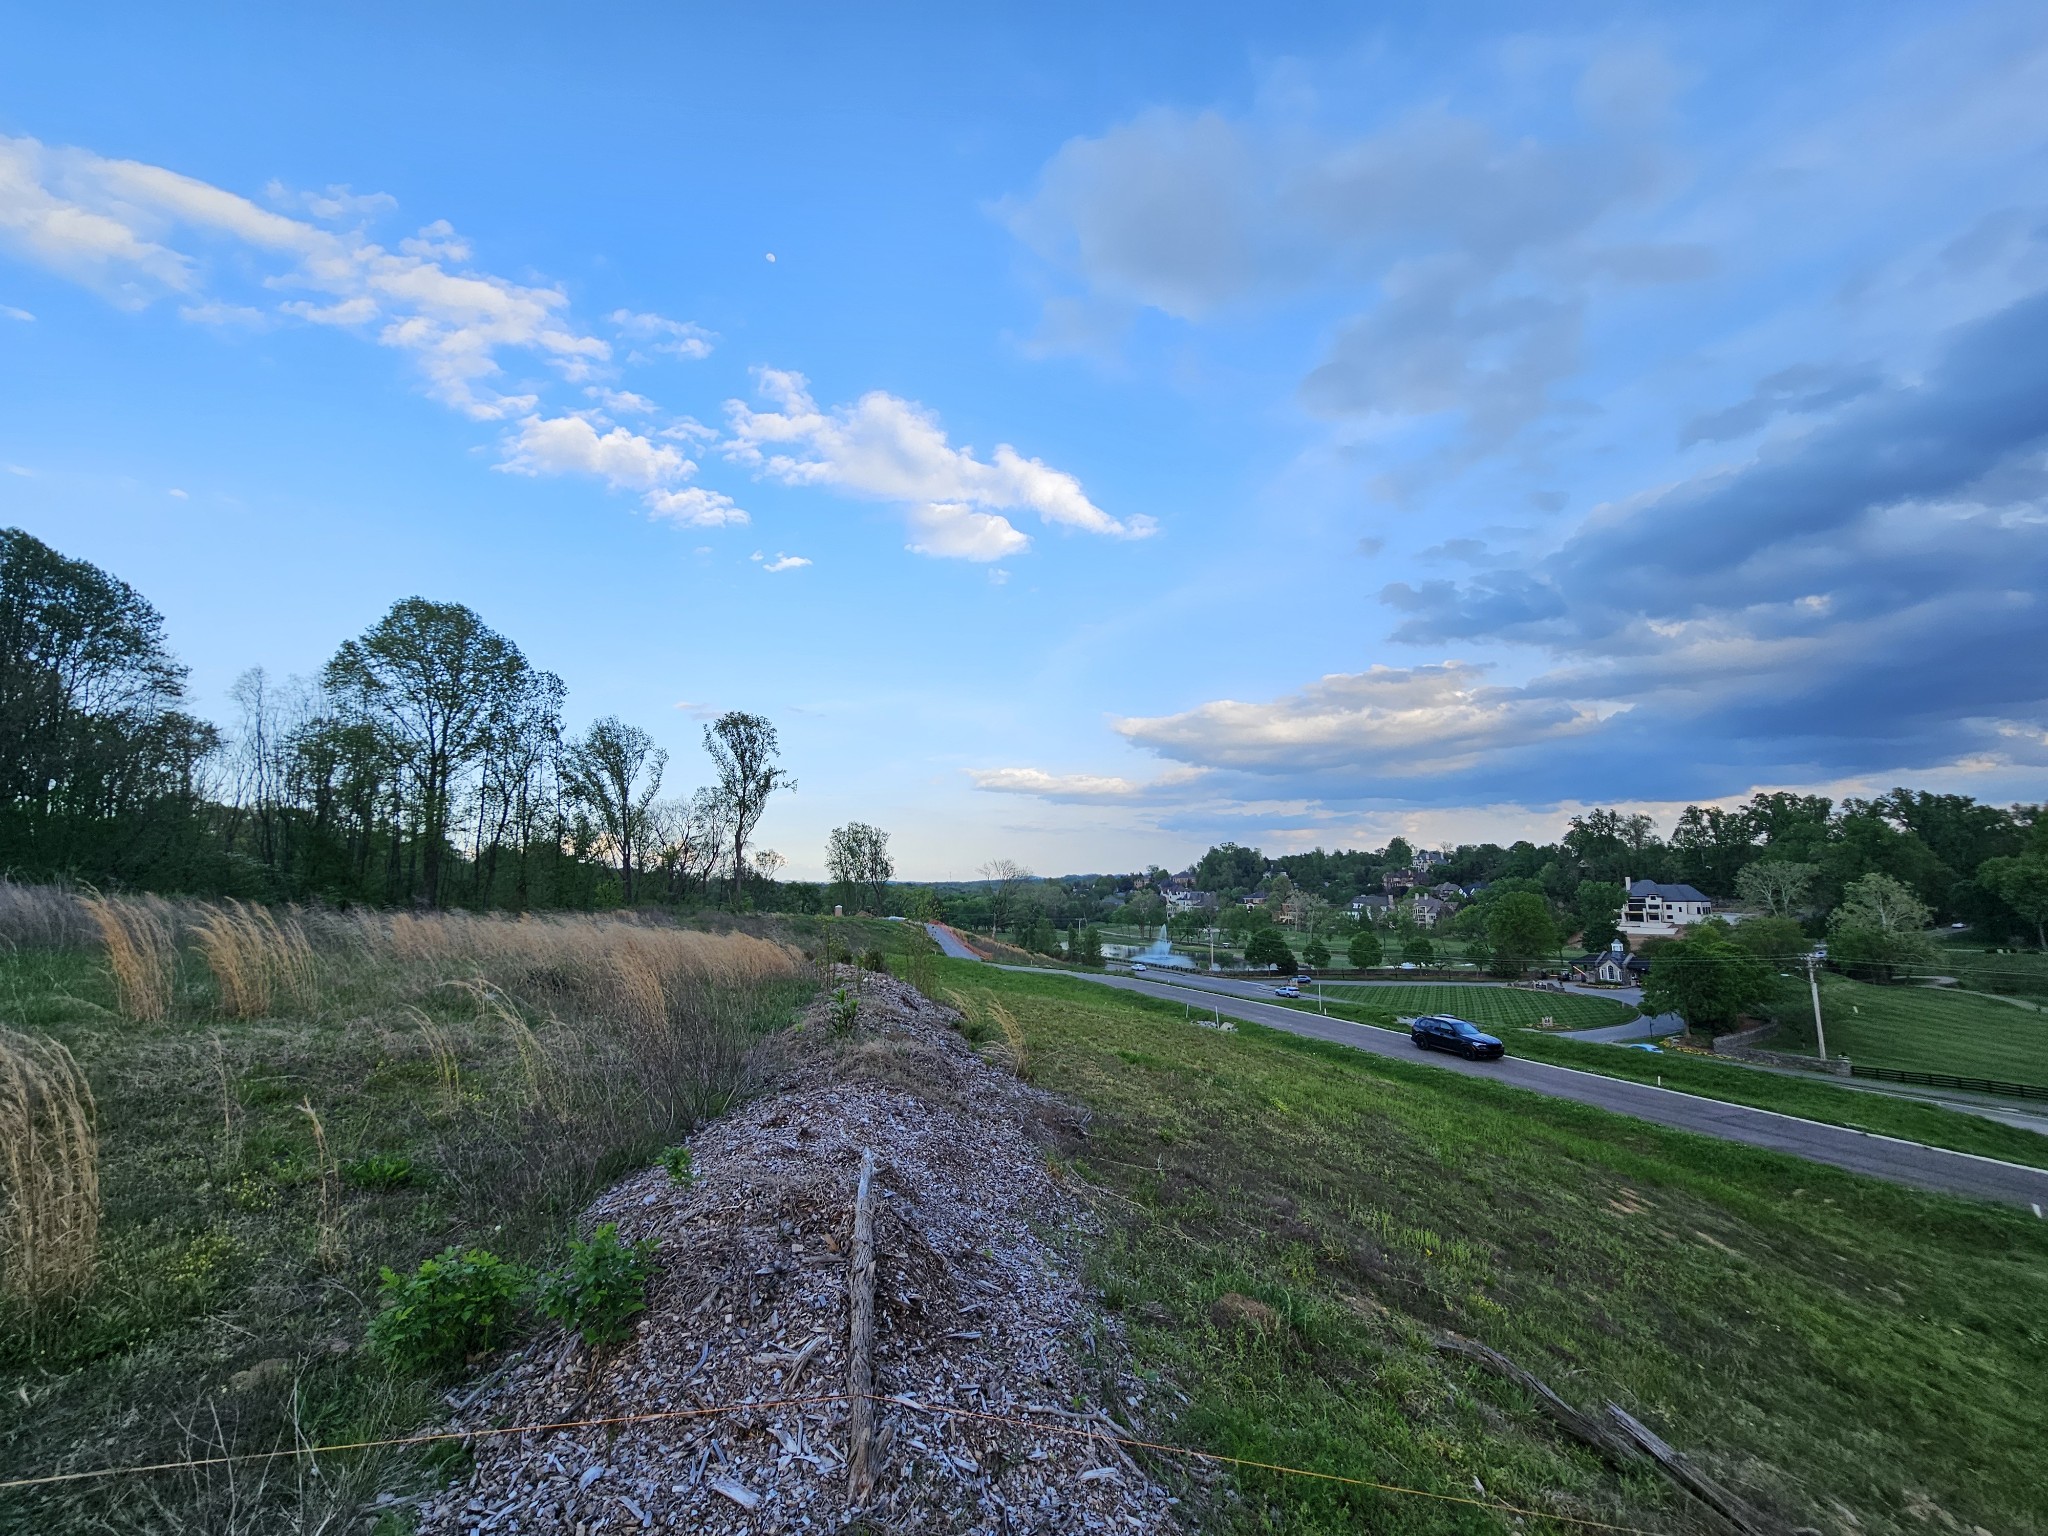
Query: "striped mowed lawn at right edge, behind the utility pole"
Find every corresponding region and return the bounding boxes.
[1769,977,2048,1087]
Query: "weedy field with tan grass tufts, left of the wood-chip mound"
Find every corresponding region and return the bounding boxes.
[0,883,922,1536]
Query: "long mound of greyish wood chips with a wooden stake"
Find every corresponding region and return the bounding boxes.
[420,975,1182,1536]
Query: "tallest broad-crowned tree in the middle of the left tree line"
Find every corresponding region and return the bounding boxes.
[322,598,528,905]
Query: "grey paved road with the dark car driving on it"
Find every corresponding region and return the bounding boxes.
[991,967,2048,1212]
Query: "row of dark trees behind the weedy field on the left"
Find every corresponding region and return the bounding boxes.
[0,528,795,907]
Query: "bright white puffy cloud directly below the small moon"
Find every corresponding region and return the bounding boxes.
[725,369,1155,559]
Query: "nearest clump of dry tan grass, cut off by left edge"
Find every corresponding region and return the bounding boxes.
[0,1030,100,1305]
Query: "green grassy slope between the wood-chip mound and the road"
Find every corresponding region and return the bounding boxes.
[942,963,2048,1536]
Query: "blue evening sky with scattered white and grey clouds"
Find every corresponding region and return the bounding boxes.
[0,4,2048,877]
